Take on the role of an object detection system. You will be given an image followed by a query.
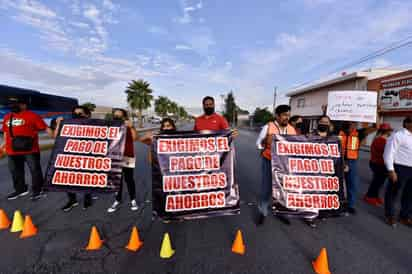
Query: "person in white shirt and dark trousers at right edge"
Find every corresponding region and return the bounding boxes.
[383,116,412,226]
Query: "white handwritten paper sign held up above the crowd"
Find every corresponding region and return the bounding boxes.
[327,90,378,123]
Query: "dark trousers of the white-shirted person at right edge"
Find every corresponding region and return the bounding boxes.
[385,164,412,219]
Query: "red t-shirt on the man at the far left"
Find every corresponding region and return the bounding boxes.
[3,110,47,155]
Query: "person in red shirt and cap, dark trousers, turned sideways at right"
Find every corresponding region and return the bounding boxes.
[363,123,393,206]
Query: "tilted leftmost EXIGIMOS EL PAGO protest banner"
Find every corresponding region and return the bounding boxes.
[45,119,126,192]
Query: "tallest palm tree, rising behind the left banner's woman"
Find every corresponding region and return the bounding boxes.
[125,79,153,128]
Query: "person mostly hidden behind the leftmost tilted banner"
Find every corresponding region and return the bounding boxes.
[53,106,92,212]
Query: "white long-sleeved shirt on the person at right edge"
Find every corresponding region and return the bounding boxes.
[383,128,412,171]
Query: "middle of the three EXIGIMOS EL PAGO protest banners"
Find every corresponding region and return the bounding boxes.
[152,131,240,220]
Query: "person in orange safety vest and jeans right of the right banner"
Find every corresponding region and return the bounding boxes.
[339,121,376,214]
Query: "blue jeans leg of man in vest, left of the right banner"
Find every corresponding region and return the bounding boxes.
[258,157,272,216]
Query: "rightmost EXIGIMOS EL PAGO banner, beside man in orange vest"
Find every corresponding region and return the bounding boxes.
[272,135,344,219]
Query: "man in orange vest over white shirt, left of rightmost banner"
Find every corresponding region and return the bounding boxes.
[256,105,296,225]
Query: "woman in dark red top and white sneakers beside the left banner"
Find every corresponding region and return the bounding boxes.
[107,108,139,213]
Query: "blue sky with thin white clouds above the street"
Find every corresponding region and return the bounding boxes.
[0,0,412,113]
